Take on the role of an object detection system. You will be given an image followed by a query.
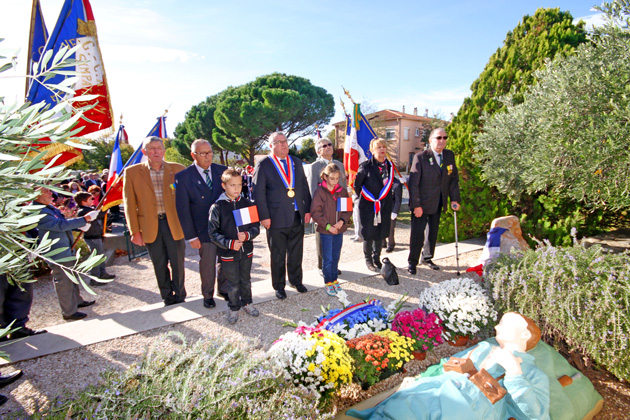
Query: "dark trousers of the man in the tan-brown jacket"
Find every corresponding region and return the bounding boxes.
[147,219,186,304]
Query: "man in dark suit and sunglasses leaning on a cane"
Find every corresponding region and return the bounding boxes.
[407,128,460,274]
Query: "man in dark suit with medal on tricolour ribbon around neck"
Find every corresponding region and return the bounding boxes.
[252,131,311,299]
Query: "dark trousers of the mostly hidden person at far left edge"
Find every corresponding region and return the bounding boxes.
[0,274,33,328]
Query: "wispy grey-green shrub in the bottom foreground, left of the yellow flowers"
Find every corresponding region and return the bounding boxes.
[28,333,331,420]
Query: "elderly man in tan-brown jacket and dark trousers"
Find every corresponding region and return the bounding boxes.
[123,137,186,306]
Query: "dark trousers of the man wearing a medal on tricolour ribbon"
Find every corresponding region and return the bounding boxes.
[267,211,304,290]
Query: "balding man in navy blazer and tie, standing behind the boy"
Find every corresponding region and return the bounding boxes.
[175,139,227,308]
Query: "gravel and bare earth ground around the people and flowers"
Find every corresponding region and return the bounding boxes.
[0,221,630,419]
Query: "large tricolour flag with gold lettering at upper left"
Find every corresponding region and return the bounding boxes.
[27,0,113,135]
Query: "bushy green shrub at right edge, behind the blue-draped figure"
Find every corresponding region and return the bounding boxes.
[484,230,630,380]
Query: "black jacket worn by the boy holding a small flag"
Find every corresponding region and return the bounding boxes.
[208,193,260,261]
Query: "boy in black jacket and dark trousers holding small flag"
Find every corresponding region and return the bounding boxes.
[208,168,260,324]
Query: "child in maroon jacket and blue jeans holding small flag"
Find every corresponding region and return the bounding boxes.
[311,163,352,296]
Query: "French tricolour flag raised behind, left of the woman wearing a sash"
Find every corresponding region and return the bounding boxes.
[343,104,378,185]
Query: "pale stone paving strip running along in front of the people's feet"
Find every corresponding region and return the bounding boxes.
[0,239,483,366]
